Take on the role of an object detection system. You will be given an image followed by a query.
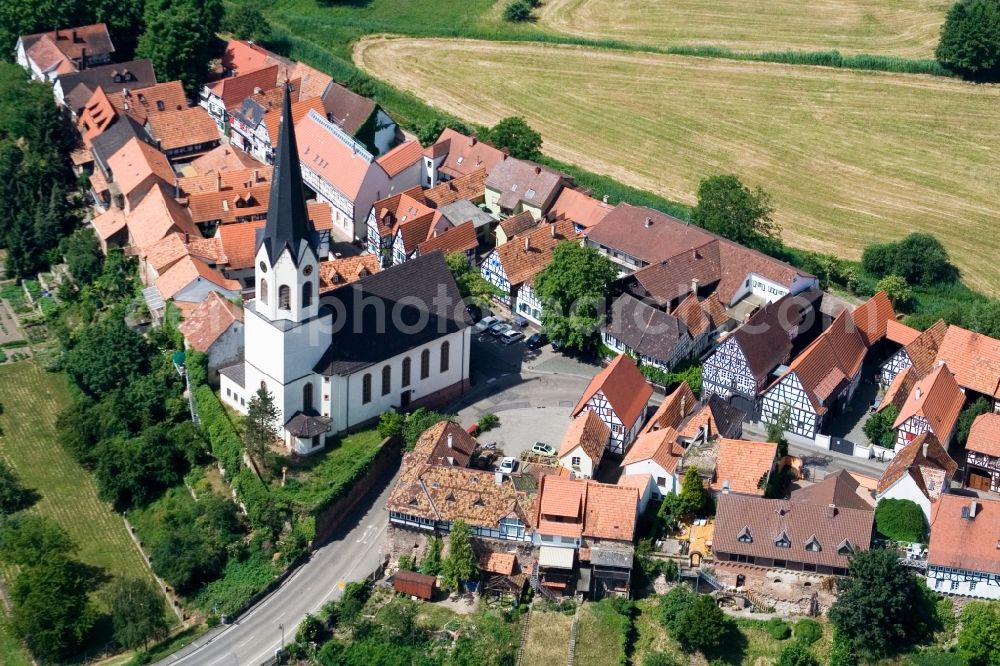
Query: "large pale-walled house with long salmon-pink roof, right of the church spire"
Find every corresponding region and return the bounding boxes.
[296,111,419,241]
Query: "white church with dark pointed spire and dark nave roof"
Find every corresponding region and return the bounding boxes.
[219,90,472,455]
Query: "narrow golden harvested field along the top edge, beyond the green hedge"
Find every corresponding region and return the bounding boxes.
[539,0,951,58]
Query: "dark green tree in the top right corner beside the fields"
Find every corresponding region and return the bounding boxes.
[934,0,1000,81]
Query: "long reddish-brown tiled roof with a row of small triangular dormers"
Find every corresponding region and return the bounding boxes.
[712,493,874,569]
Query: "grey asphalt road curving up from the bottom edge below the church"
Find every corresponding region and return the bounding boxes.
[157,466,396,666]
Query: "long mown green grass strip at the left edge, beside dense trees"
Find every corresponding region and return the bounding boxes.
[0,362,162,604]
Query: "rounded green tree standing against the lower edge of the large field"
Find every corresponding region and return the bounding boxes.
[691,174,781,252]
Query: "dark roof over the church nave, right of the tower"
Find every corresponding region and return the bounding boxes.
[315,252,470,376]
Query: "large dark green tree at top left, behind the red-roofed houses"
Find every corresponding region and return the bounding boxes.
[136,0,223,95]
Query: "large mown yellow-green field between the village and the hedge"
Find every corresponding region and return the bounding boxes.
[354,37,1000,295]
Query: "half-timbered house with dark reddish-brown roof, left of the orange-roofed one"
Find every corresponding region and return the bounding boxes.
[701,289,823,421]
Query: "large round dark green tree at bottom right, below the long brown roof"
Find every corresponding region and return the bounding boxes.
[829,549,933,660]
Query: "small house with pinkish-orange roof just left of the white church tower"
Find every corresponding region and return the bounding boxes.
[178,291,243,382]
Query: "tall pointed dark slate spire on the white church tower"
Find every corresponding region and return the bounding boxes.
[257,84,312,266]
